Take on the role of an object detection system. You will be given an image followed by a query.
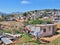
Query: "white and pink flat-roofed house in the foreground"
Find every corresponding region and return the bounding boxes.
[27,24,57,37]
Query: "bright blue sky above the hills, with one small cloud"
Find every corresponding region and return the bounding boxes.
[0,0,60,13]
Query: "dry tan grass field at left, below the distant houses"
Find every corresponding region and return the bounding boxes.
[0,21,23,30]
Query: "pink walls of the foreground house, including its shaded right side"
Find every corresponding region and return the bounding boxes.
[35,25,57,37]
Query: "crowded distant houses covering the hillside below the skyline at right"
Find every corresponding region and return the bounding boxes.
[20,11,60,22]
